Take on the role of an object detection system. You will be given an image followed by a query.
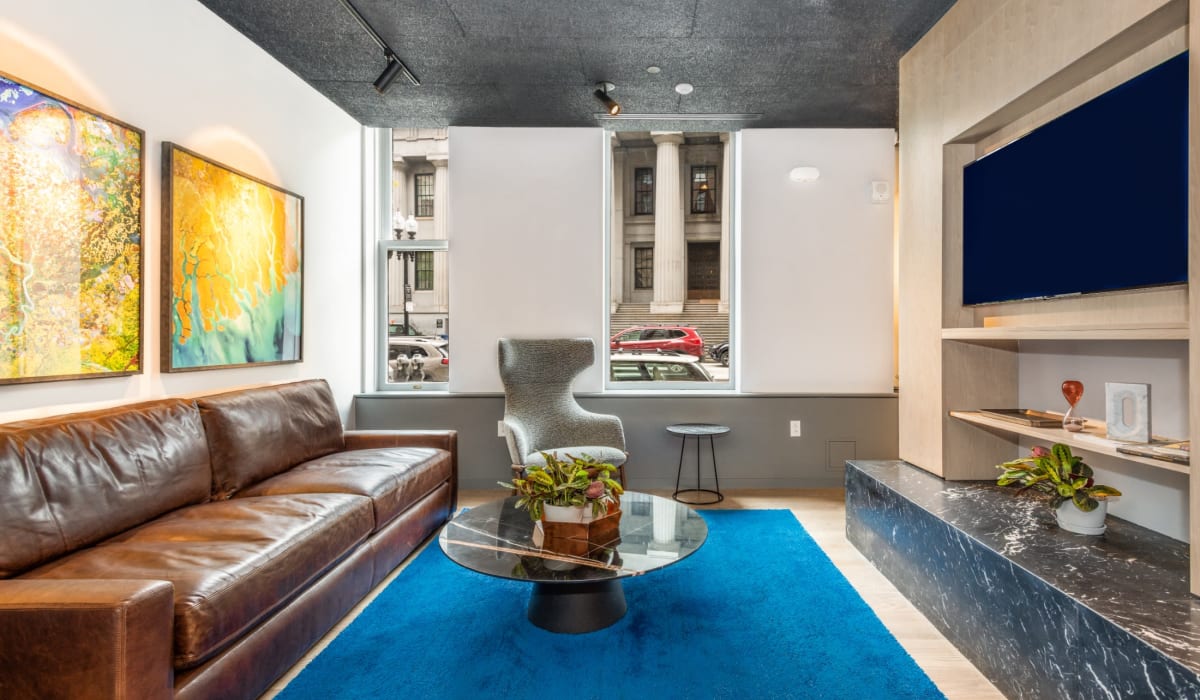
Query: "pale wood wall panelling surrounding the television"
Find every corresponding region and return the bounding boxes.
[898,0,1185,482]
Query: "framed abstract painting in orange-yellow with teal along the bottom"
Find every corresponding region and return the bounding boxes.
[162,143,304,372]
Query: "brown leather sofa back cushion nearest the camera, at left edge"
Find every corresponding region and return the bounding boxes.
[0,399,212,578]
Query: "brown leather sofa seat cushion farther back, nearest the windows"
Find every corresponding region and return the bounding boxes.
[238,447,454,531]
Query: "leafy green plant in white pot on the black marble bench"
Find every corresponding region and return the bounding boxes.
[996,443,1121,534]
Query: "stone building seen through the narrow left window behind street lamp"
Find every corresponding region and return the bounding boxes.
[388,128,450,335]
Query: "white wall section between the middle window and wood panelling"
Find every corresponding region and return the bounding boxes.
[738,128,895,394]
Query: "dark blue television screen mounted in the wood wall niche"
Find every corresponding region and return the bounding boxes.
[962,53,1188,305]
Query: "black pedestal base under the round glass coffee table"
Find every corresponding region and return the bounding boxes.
[529,579,625,634]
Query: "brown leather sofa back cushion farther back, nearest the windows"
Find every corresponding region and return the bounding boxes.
[196,379,346,498]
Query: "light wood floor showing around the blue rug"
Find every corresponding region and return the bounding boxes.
[264,489,1003,700]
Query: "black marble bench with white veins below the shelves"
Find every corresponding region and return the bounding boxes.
[846,461,1200,700]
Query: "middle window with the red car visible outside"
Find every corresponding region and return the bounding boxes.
[604,132,740,393]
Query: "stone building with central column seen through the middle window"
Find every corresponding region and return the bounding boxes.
[610,131,731,316]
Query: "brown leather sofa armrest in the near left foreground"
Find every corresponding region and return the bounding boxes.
[0,579,174,700]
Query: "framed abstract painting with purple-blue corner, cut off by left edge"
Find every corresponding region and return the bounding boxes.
[0,73,145,384]
